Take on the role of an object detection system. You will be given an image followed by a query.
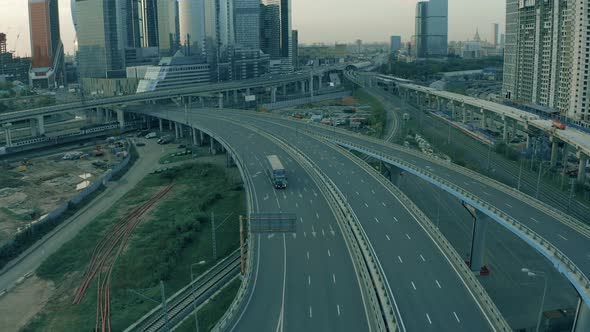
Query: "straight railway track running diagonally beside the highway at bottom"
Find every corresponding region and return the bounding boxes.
[125,250,240,332]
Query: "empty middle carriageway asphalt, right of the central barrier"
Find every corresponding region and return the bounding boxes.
[210,112,498,331]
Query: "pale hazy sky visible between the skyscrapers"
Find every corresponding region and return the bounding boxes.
[0,0,506,55]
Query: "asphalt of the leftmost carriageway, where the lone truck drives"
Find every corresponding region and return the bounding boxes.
[148,112,368,331]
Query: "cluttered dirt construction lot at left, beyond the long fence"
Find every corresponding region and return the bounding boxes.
[0,145,123,246]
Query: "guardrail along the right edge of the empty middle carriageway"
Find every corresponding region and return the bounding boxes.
[332,141,512,332]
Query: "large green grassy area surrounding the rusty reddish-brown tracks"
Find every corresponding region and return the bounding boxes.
[23,164,246,331]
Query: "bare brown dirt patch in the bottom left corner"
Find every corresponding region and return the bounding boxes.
[0,275,55,332]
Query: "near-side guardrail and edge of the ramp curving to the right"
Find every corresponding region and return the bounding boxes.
[324,135,590,303]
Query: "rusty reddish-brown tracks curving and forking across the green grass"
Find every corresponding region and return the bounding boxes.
[73,185,173,332]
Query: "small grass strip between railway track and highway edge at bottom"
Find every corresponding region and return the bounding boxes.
[175,278,241,332]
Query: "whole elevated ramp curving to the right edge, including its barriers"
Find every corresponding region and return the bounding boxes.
[209,109,590,303]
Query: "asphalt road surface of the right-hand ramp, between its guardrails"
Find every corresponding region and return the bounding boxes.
[229,112,590,275]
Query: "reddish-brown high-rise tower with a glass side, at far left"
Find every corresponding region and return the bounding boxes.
[29,0,64,88]
